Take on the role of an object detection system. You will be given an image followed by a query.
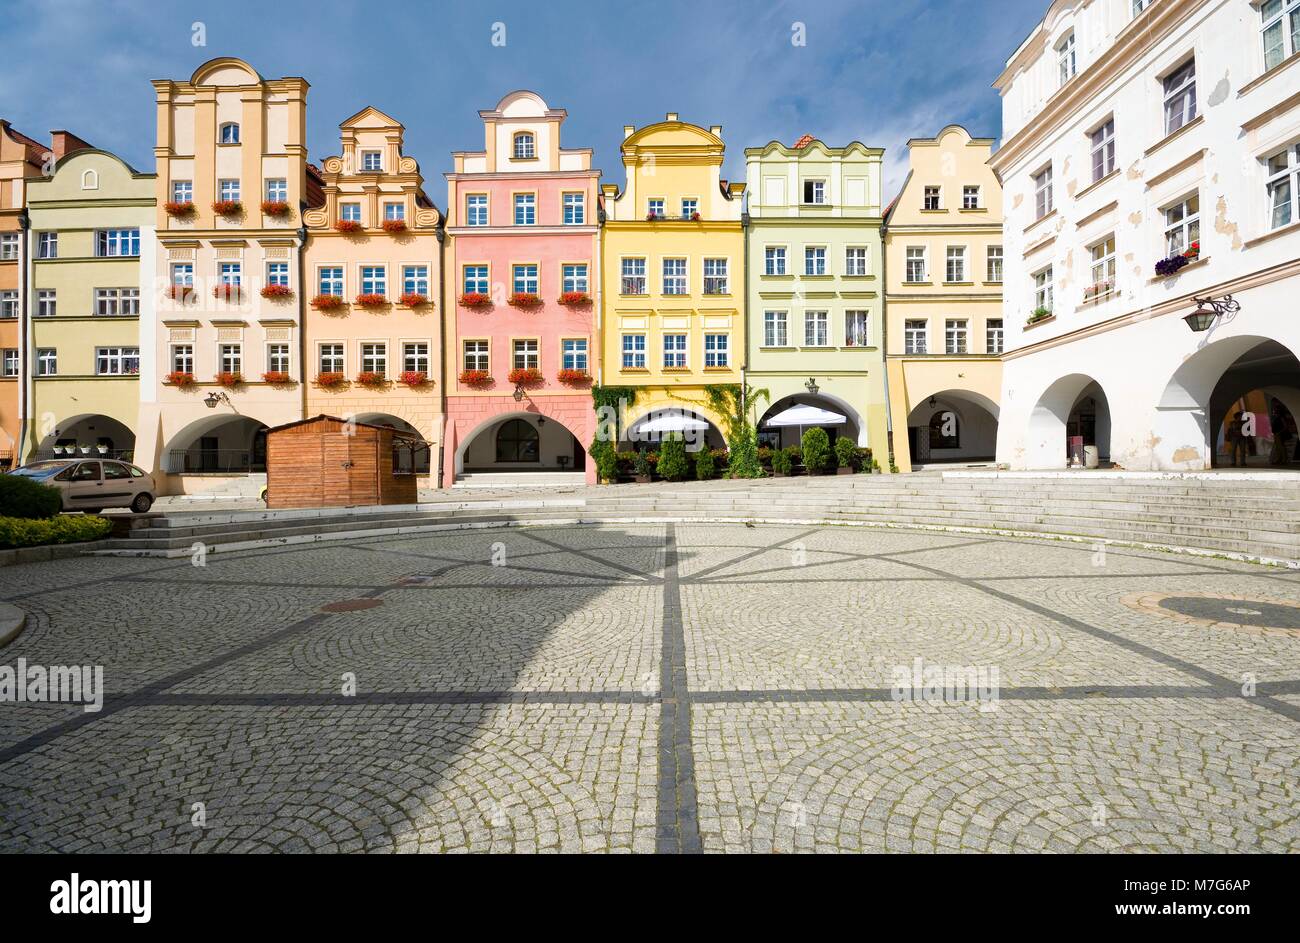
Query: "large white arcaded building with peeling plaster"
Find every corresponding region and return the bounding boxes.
[991,0,1300,471]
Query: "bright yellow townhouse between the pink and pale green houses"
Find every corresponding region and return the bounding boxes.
[598,113,745,447]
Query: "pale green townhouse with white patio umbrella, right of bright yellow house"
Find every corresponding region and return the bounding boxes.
[745,135,889,467]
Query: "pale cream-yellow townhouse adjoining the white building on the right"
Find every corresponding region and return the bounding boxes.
[884,125,1002,471]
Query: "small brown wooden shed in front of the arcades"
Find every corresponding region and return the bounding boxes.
[267,415,429,509]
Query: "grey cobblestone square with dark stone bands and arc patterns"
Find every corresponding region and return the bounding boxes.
[0,524,1300,852]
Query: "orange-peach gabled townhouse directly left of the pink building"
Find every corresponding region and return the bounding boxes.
[303,108,442,484]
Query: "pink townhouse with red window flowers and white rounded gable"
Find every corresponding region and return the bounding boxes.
[443,91,599,485]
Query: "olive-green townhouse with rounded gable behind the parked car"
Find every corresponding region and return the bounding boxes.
[22,148,156,460]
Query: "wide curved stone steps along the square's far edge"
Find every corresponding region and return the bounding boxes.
[99,472,1300,567]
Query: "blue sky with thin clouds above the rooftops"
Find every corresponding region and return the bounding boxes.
[0,0,1048,206]
